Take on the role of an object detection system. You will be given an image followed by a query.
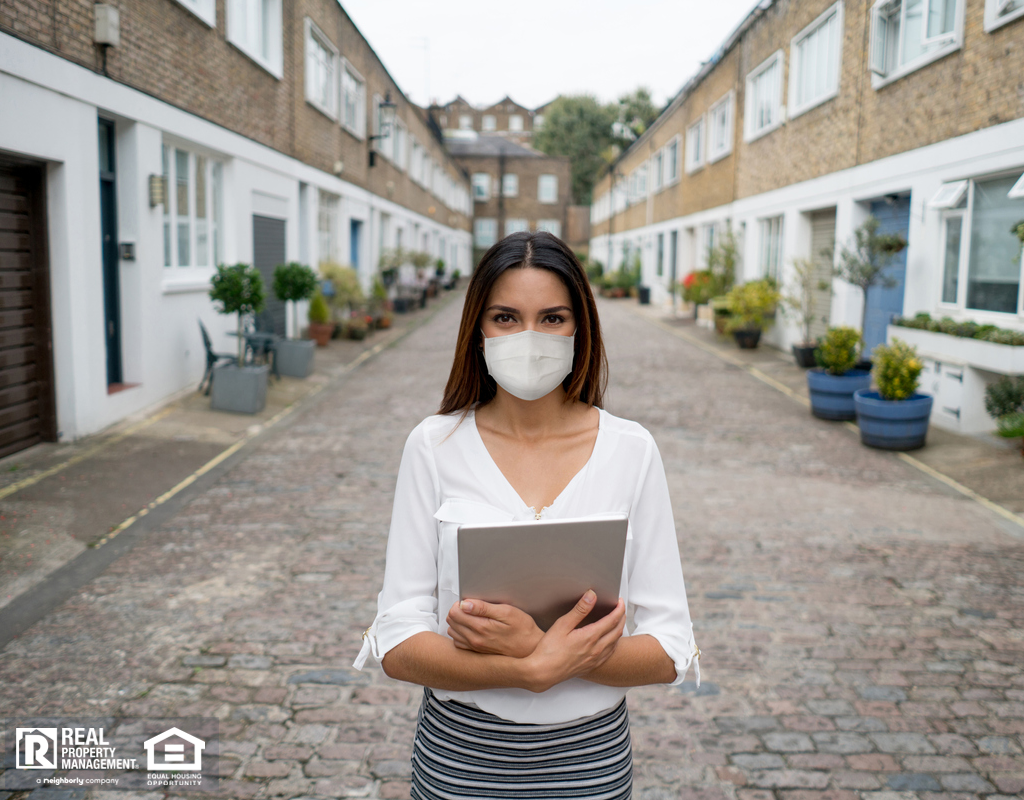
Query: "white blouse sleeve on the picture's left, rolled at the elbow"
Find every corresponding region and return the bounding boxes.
[352,421,439,669]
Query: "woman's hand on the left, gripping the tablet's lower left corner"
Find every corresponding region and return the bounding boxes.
[446,600,544,659]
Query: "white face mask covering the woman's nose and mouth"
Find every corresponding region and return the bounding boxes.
[483,331,575,401]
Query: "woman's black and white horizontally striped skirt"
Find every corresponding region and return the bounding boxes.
[412,688,633,800]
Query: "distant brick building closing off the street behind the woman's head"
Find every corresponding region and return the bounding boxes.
[447,135,571,262]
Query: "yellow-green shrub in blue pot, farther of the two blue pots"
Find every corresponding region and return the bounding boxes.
[807,326,871,420]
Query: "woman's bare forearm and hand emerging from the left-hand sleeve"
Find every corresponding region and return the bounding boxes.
[381,591,626,691]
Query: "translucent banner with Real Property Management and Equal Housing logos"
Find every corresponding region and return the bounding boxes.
[0,718,219,791]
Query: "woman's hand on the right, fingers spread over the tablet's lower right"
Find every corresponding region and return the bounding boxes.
[525,589,626,691]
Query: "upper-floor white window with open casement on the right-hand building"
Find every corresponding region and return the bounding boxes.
[870,0,963,88]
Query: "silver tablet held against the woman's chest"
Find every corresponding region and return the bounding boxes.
[458,516,627,631]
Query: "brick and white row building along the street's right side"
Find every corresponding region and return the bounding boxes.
[591,0,1024,432]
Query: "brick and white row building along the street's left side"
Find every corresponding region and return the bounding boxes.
[0,0,473,448]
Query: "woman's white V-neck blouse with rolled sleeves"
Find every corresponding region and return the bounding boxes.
[352,409,700,724]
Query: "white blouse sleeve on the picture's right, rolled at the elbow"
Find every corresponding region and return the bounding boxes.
[628,438,700,686]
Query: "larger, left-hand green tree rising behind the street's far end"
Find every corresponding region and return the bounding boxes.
[534,94,616,205]
